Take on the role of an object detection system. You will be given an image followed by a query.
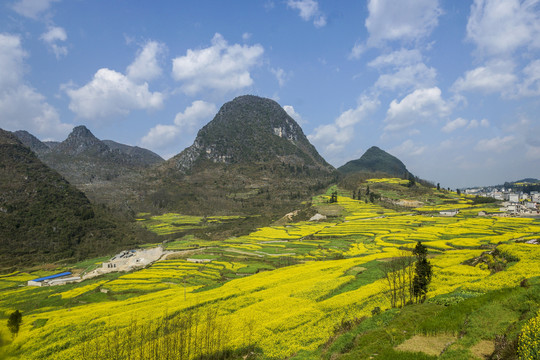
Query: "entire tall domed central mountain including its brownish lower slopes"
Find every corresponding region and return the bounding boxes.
[141,95,338,216]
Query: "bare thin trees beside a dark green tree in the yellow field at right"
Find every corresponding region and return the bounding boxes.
[383,241,433,307]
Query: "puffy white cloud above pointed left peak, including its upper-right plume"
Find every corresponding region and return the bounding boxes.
[65,42,164,120]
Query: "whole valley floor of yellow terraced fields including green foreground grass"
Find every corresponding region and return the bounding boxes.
[0,179,540,359]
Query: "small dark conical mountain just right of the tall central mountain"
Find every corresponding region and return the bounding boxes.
[338,146,412,179]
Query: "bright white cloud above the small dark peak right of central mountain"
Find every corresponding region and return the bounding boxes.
[384,87,451,131]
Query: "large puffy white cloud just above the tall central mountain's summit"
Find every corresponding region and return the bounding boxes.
[172,34,264,95]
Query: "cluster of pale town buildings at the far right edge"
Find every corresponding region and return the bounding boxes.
[464,188,540,216]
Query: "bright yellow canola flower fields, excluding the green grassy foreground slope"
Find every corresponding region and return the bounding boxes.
[0,179,540,359]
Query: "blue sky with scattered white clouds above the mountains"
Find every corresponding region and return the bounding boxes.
[0,0,540,188]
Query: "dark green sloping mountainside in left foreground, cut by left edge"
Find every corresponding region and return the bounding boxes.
[0,129,148,271]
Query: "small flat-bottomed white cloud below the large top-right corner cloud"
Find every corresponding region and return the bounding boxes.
[452,60,517,95]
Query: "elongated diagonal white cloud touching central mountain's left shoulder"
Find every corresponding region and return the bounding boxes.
[141,100,216,149]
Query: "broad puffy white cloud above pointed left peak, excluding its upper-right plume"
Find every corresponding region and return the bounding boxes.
[66,68,163,120]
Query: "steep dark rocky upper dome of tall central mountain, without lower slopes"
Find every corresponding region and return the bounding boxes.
[171,95,333,172]
